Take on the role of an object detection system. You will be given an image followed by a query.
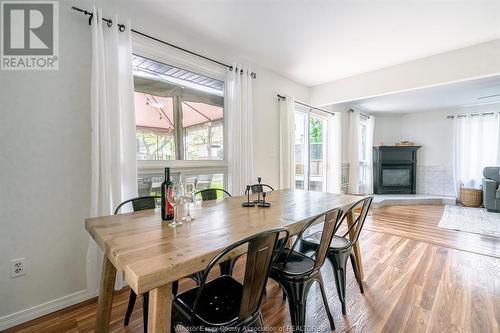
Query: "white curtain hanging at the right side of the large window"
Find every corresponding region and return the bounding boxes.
[226,65,255,195]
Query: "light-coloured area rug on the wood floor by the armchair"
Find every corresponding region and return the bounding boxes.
[438,205,500,237]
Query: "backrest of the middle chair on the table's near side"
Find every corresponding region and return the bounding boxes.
[282,209,342,276]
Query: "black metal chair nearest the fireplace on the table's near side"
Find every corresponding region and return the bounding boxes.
[300,196,373,315]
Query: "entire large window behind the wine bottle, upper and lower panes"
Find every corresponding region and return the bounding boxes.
[132,51,226,195]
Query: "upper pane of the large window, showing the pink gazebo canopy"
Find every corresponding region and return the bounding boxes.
[133,55,224,160]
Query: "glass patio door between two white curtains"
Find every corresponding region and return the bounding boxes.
[295,108,327,191]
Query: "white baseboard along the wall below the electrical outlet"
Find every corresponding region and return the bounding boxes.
[0,289,97,331]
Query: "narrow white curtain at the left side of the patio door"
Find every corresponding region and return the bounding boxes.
[279,96,295,189]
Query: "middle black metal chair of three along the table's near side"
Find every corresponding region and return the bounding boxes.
[270,209,342,331]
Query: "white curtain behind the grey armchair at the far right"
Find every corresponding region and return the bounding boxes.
[453,114,500,196]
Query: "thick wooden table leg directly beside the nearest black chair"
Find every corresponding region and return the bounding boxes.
[148,283,173,333]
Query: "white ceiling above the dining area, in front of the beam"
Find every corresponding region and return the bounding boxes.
[111,0,500,86]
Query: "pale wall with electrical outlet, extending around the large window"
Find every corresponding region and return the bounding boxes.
[0,0,309,330]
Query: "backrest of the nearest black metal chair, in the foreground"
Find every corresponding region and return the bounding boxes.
[191,228,289,322]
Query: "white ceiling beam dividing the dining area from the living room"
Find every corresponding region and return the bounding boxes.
[311,39,500,105]
